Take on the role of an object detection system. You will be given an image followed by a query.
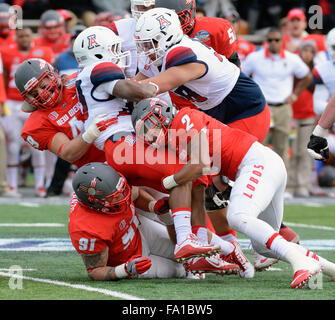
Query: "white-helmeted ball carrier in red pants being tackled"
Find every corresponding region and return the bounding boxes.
[73,27,242,268]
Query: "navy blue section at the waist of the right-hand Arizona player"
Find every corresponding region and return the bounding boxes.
[203,72,266,124]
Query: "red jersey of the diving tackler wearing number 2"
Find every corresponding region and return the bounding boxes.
[169,108,257,181]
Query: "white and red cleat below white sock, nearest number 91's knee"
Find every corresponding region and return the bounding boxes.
[174,233,220,262]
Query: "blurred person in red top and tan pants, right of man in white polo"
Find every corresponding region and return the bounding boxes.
[288,40,317,197]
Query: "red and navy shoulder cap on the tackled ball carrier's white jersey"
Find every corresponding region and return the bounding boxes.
[90,62,125,87]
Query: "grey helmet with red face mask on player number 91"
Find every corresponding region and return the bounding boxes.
[73,162,131,214]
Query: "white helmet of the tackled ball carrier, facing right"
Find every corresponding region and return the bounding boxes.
[73,26,131,68]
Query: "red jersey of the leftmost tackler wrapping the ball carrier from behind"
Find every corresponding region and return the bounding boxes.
[21,78,105,167]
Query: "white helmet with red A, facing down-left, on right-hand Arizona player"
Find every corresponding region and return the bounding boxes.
[135,8,184,66]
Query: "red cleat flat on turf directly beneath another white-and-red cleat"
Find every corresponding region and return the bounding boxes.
[184,254,240,275]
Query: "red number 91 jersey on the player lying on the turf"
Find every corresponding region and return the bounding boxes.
[68,195,142,267]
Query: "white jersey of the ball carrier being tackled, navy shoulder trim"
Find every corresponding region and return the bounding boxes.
[76,62,134,150]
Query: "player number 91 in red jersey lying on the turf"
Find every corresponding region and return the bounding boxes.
[68,162,185,281]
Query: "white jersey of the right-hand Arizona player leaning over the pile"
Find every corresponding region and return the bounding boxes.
[161,36,240,110]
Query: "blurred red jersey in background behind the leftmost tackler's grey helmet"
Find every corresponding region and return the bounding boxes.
[2,47,54,101]
